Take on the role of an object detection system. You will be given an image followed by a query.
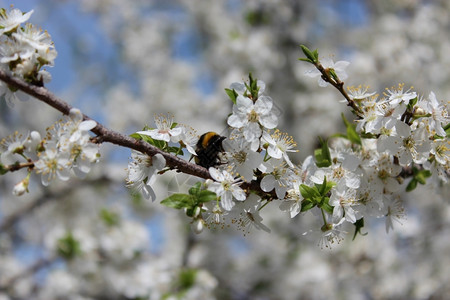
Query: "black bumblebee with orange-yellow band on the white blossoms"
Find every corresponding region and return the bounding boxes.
[195,131,225,168]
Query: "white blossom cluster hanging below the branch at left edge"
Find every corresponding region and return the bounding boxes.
[0,108,100,196]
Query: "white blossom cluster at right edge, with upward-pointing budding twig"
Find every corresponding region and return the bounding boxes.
[302,48,450,245]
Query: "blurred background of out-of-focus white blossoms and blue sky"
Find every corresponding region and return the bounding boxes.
[0,0,450,300]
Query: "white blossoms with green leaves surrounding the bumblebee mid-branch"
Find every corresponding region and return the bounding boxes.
[127,75,301,234]
